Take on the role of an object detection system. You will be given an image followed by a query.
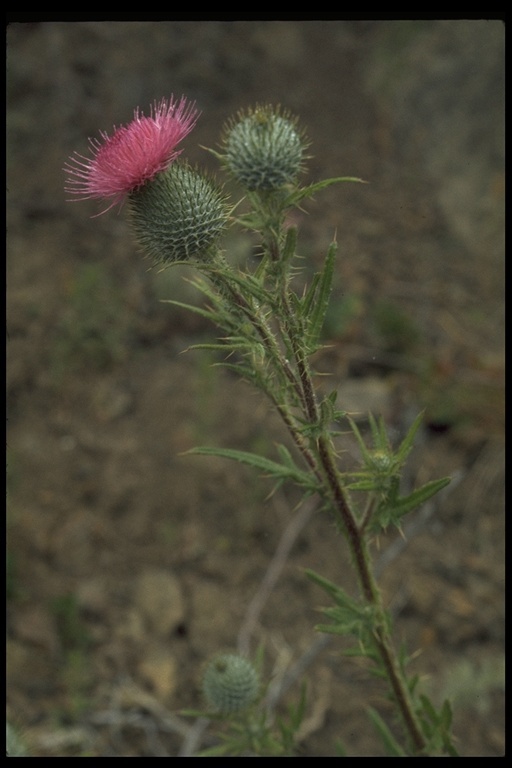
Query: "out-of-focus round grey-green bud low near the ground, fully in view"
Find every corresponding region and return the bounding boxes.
[203,653,259,712]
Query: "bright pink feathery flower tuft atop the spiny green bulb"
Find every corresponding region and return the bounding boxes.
[64,96,199,213]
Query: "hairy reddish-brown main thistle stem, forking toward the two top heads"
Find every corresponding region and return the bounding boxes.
[210,219,426,753]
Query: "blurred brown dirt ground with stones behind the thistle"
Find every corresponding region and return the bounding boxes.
[7,21,505,756]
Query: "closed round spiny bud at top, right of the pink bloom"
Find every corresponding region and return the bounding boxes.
[224,106,306,190]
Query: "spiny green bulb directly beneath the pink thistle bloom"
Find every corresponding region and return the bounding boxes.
[129,163,228,264]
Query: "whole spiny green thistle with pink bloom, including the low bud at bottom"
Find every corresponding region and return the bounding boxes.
[66,98,457,756]
